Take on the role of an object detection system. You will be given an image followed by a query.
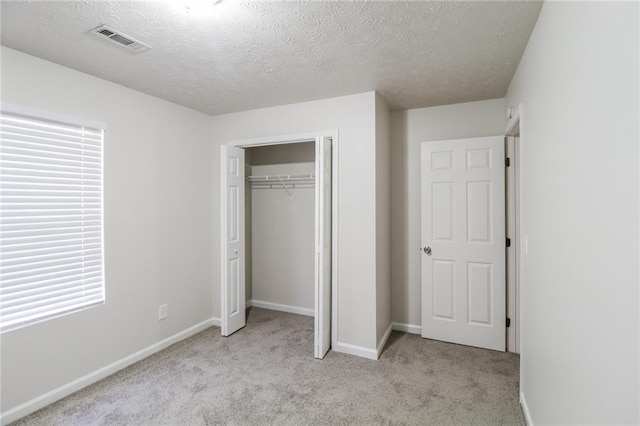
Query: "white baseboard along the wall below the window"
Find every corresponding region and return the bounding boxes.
[0,318,220,425]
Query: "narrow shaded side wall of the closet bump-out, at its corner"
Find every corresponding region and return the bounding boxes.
[375,94,391,349]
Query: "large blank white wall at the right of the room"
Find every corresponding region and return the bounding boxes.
[507,2,640,424]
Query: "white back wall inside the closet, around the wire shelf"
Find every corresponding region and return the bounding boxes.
[245,142,315,316]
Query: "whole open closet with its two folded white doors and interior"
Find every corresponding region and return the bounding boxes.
[221,135,336,358]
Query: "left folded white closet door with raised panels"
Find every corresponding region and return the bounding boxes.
[220,146,246,336]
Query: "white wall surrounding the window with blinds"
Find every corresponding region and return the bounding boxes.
[0,47,212,412]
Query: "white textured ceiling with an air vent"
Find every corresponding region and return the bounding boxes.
[0,0,541,115]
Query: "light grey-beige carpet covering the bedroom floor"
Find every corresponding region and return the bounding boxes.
[14,308,524,426]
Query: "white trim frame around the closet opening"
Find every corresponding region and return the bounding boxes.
[220,130,340,354]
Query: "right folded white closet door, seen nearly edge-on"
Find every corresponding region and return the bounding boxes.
[314,137,331,359]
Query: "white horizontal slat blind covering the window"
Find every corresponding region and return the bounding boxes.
[0,112,105,332]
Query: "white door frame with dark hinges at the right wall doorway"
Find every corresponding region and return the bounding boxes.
[505,103,527,352]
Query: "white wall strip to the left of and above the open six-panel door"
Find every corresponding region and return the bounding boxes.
[391,99,505,332]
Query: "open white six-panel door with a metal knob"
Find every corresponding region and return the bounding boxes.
[420,136,506,351]
